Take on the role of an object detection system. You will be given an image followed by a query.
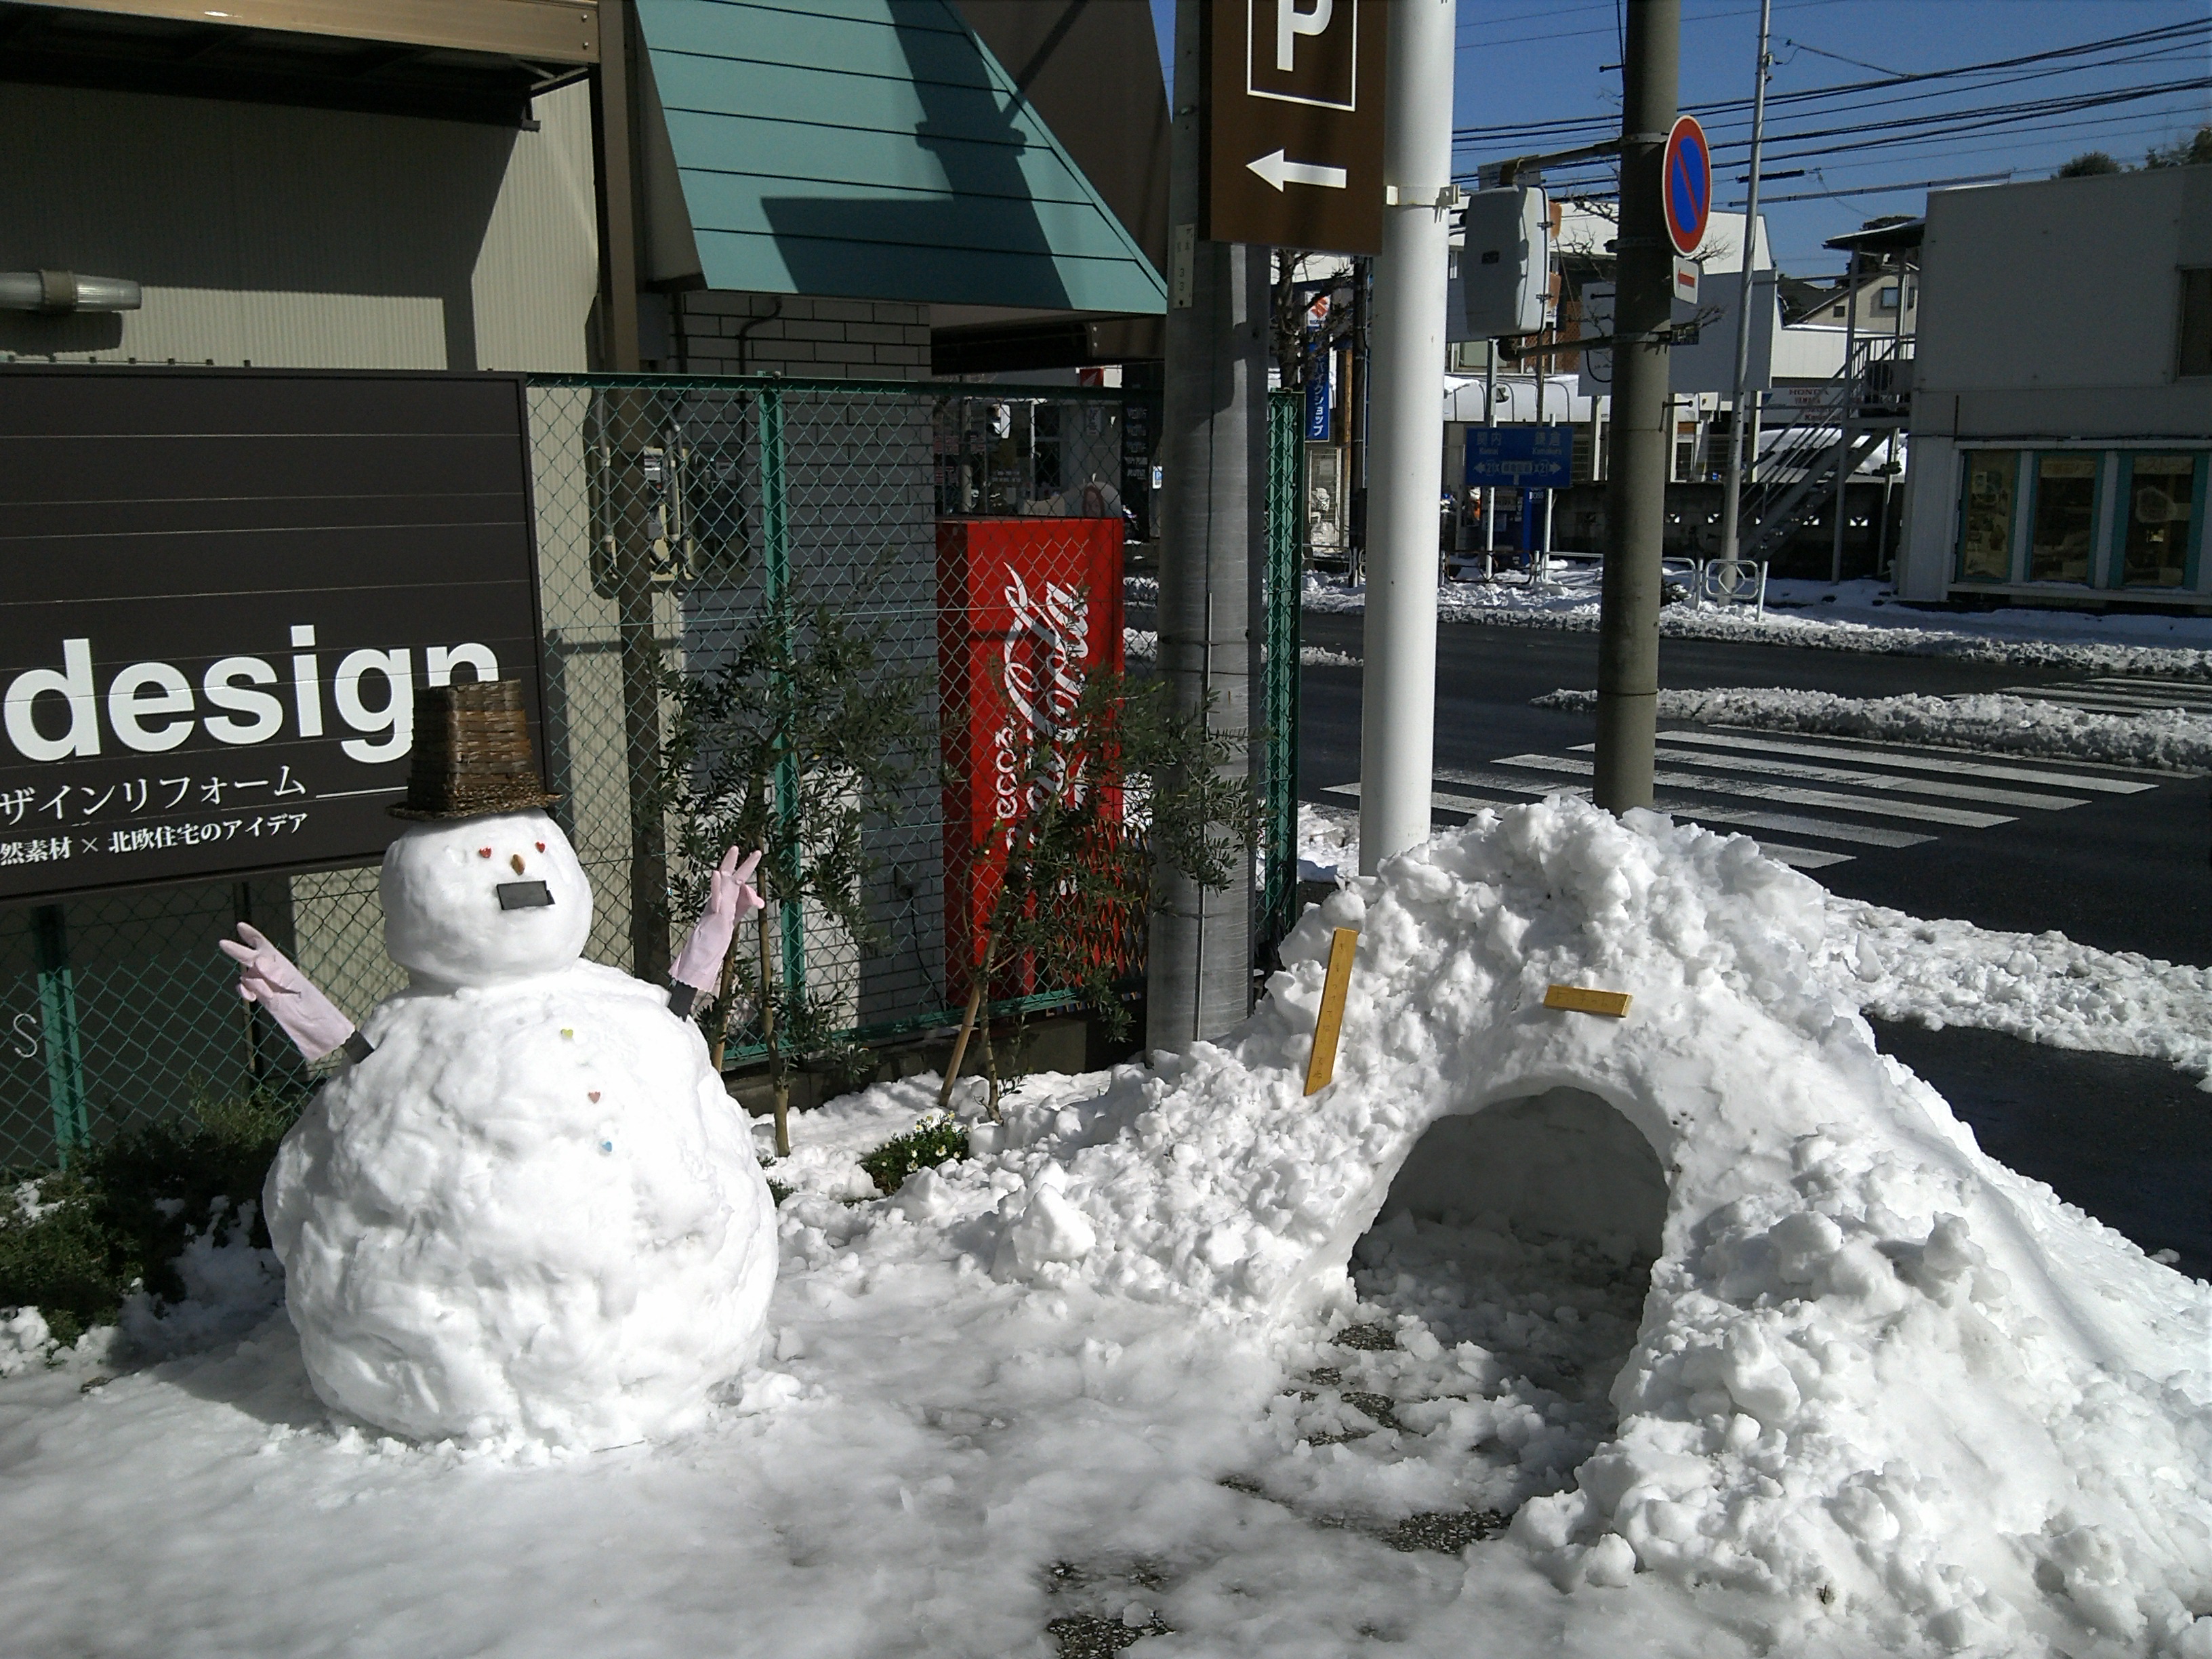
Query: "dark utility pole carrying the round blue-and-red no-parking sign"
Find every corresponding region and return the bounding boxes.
[1593,0,1681,812]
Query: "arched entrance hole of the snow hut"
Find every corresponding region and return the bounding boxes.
[1307,1088,1668,1513]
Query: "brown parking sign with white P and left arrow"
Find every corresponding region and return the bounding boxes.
[1199,0,1389,254]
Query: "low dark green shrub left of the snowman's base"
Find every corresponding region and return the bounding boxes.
[0,1092,303,1343]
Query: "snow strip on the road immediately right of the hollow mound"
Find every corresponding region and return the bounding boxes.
[1818,898,2212,1092]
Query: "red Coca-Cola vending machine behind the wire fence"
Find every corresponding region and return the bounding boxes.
[938,518,1124,996]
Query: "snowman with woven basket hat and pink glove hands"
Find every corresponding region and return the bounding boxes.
[224,681,777,1447]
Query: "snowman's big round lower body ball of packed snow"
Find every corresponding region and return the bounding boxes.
[263,962,777,1447]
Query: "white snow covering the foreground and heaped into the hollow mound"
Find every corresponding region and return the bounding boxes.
[0,801,2212,1659]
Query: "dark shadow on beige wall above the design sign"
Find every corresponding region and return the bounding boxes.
[0,86,516,369]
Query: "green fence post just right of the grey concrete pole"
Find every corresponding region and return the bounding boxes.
[1261,392,1305,954]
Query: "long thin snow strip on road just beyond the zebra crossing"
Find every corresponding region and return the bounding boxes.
[1533,686,2212,772]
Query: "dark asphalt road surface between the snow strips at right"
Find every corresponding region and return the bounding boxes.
[1298,613,2212,1276]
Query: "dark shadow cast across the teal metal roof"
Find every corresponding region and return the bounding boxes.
[761,0,1069,310]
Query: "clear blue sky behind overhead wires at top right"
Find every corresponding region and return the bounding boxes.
[1150,0,2212,274]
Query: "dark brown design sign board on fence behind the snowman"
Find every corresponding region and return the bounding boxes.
[0,365,544,903]
